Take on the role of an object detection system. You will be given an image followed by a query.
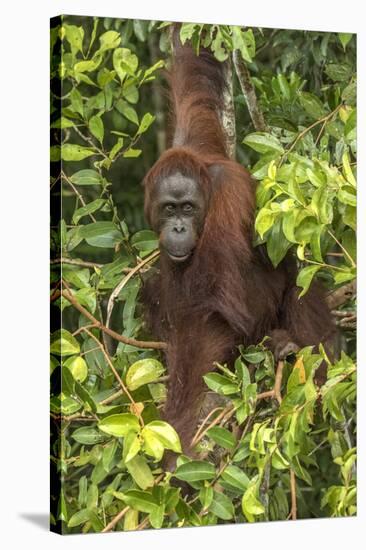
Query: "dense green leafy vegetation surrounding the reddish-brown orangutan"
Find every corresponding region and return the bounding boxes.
[51,16,356,533]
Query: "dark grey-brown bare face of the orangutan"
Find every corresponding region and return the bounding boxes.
[152,173,206,263]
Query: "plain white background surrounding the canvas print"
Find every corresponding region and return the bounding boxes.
[0,0,366,550]
